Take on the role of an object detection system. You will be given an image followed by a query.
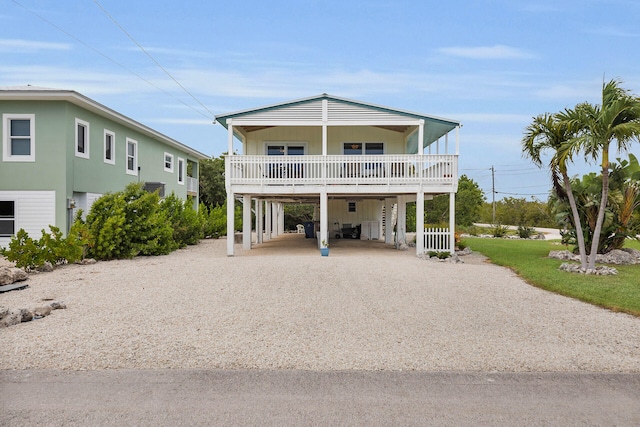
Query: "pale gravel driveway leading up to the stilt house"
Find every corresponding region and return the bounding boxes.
[0,235,640,372]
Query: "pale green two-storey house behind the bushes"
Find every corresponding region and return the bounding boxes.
[0,86,207,246]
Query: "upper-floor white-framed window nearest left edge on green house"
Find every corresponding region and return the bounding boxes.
[2,114,36,162]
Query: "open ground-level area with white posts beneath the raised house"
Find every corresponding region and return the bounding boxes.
[227,192,455,256]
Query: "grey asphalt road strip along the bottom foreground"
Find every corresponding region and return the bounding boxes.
[0,370,640,426]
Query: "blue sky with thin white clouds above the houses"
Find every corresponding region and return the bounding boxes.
[0,0,640,200]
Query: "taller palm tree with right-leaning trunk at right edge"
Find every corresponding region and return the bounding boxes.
[564,80,640,272]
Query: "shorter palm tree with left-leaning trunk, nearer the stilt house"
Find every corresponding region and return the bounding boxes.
[522,113,587,270]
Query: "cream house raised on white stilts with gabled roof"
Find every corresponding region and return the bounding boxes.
[216,94,460,256]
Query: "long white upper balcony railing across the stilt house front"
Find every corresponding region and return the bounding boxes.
[225,154,458,185]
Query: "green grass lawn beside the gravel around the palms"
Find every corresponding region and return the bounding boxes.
[462,237,640,316]
